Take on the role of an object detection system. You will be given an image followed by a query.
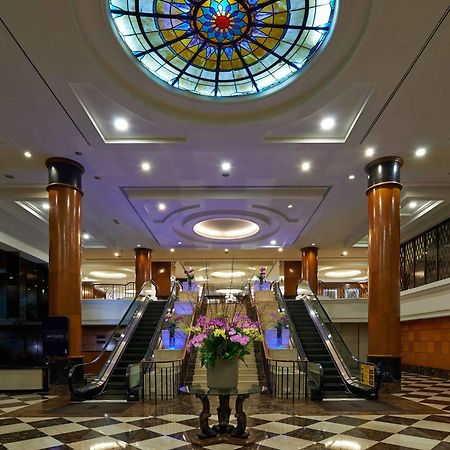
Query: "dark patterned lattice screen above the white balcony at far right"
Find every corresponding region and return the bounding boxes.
[400,219,450,291]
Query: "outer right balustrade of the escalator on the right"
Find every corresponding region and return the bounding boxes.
[296,282,380,398]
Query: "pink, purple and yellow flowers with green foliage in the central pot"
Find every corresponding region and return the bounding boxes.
[187,314,262,368]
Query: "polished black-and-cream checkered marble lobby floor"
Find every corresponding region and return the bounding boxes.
[0,374,450,450]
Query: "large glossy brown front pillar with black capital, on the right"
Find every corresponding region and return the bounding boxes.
[365,156,403,392]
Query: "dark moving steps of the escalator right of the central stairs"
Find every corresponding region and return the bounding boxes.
[286,300,348,398]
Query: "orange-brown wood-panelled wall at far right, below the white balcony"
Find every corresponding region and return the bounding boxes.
[401,317,450,370]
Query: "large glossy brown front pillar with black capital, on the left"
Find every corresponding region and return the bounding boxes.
[45,158,84,358]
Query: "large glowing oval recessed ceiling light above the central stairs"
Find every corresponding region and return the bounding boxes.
[193,217,259,240]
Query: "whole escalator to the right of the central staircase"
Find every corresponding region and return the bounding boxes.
[274,282,380,399]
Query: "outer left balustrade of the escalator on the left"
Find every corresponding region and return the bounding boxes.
[69,281,157,400]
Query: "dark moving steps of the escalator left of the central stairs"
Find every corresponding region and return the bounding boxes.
[99,301,166,400]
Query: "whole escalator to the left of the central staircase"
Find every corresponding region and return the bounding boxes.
[69,282,172,401]
